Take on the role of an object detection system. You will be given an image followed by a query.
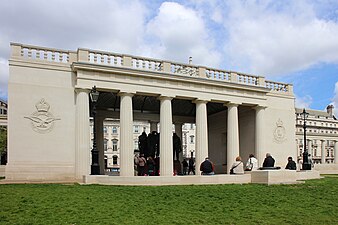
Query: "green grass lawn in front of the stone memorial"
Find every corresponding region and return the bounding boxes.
[0,175,338,225]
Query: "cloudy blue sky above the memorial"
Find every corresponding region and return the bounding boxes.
[0,0,338,116]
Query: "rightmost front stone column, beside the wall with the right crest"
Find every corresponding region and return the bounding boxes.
[255,106,266,167]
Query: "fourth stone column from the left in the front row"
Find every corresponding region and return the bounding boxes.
[195,100,208,175]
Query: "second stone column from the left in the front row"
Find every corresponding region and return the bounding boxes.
[119,92,134,177]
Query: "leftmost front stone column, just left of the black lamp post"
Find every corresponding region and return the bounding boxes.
[75,89,91,180]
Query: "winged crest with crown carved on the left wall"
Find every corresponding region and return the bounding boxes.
[25,99,60,133]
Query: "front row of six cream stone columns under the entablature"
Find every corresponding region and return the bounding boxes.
[75,89,264,179]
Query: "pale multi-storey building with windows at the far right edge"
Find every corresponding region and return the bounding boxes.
[296,105,338,164]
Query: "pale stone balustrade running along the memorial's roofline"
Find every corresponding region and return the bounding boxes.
[11,43,293,94]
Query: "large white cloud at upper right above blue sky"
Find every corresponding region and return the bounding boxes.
[219,0,338,75]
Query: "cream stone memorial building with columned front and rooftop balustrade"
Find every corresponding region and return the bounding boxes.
[6,43,297,180]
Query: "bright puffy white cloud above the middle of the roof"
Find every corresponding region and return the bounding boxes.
[147,2,221,66]
